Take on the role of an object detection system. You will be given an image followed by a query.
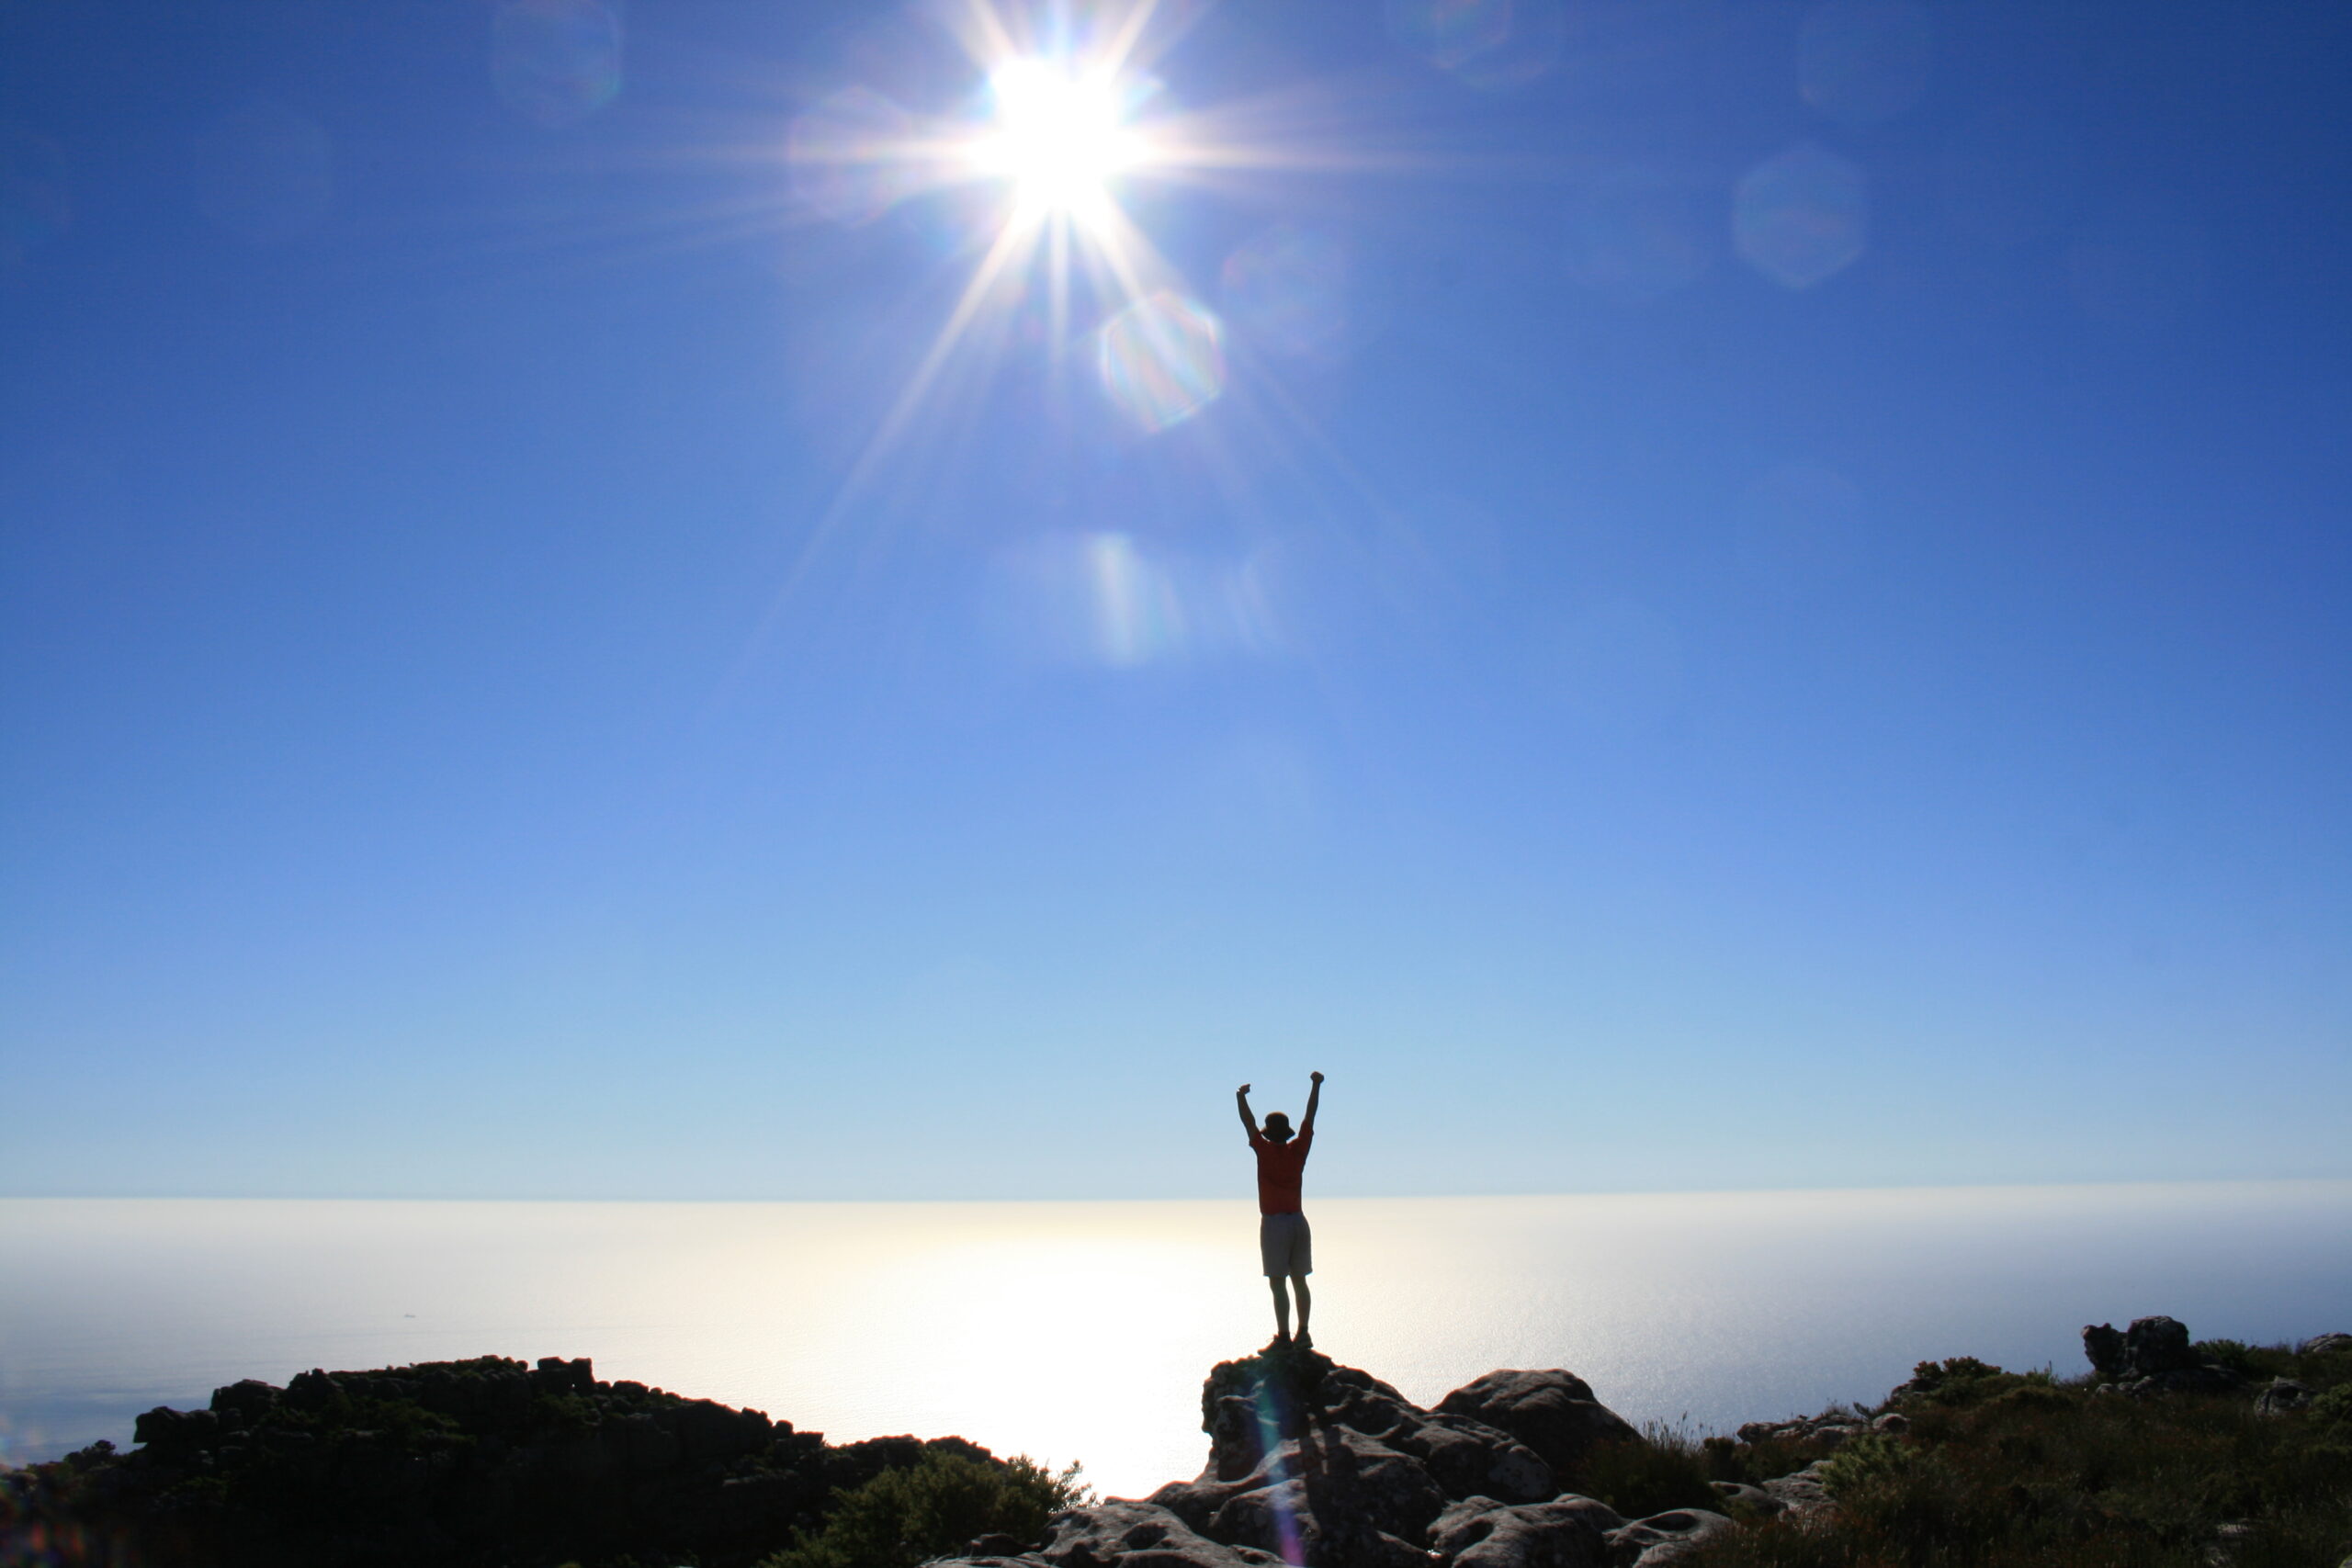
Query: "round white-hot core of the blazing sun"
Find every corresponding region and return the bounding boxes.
[971,59,1143,221]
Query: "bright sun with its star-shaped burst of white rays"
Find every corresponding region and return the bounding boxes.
[762,0,1339,592]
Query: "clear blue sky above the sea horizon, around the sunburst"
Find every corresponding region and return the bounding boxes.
[0,0,2352,1199]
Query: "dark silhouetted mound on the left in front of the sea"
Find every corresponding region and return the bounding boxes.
[0,1357,1028,1568]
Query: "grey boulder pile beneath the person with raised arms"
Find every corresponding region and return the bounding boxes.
[926,1345,1729,1568]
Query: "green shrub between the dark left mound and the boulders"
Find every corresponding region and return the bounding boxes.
[762,1448,1091,1568]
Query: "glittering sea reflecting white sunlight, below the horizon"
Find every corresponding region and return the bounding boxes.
[0,1182,2352,1495]
